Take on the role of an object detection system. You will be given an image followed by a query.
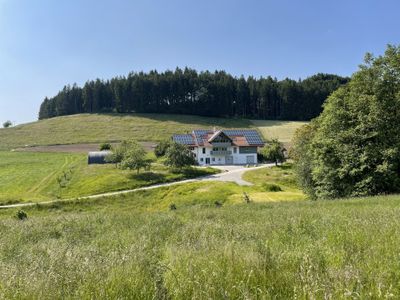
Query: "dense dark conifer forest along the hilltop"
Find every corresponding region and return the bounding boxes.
[39,68,349,120]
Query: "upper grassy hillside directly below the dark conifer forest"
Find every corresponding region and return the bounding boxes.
[0,114,303,150]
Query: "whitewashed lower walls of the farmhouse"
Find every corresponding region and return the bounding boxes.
[192,146,258,165]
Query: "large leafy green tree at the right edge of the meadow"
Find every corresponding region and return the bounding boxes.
[297,45,400,198]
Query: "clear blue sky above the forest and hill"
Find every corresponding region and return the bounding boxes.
[0,0,400,123]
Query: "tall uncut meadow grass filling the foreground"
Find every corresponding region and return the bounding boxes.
[0,195,400,299]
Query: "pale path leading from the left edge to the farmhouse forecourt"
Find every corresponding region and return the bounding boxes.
[0,164,274,209]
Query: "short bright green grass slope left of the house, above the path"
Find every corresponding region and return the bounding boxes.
[0,152,216,205]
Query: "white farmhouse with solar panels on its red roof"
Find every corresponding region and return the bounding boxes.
[172,129,264,165]
